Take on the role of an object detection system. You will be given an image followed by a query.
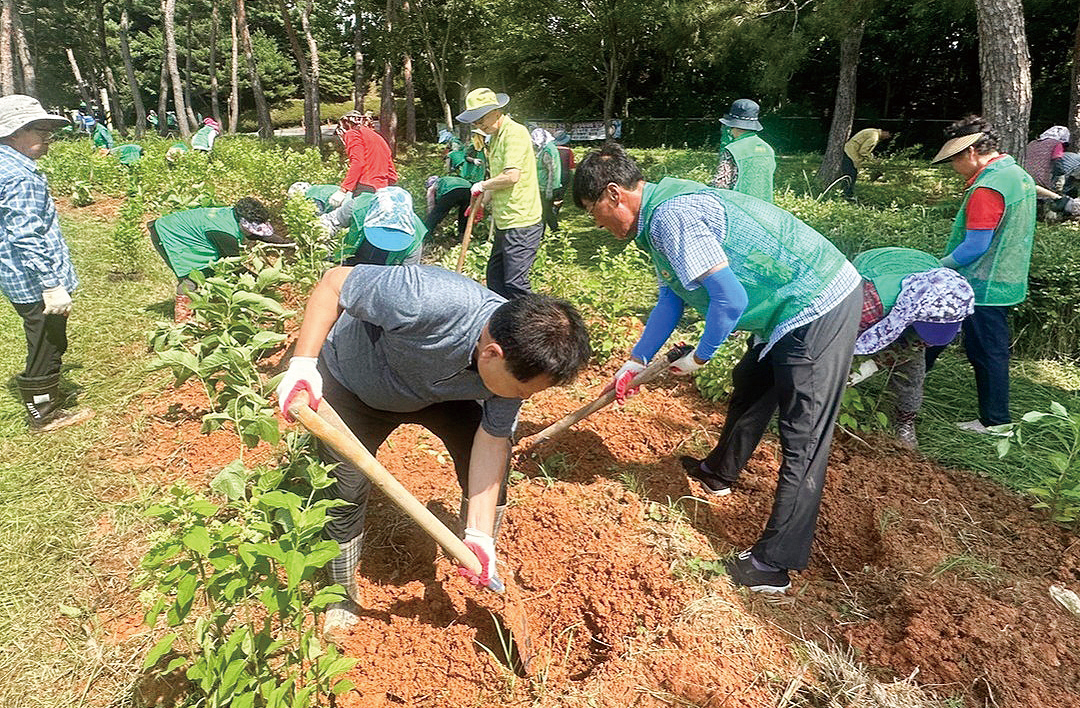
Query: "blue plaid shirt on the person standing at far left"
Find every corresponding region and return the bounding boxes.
[0,145,79,304]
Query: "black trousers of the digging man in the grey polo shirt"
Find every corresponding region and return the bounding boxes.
[319,360,509,543]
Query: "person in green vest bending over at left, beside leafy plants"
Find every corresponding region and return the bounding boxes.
[146,196,293,322]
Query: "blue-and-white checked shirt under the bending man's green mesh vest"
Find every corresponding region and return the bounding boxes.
[637,194,862,356]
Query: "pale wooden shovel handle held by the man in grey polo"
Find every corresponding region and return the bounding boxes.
[288,391,484,575]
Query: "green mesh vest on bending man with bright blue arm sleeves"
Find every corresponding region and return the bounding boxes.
[634,177,846,339]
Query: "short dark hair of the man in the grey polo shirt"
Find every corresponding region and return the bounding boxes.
[487,292,592,385]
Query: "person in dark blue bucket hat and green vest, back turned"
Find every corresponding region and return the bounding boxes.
[713,98,777,203]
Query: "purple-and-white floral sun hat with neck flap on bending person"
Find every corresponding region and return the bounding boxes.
[855,268,975,355]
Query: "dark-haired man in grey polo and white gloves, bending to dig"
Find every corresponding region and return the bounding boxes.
[278,266,591,639]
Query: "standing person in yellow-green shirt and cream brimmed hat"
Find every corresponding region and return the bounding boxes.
[457,89,543,298]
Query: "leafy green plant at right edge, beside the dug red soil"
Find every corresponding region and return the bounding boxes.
[991,401,1080,528]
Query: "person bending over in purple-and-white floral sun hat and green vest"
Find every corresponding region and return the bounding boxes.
[851,248,975,450]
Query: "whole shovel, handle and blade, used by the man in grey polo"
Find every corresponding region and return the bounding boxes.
[288,392,534,676]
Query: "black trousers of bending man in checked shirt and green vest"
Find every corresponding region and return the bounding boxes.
[705,287,863,570]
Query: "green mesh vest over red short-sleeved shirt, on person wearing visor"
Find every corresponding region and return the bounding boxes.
[945,155,1035,305]
